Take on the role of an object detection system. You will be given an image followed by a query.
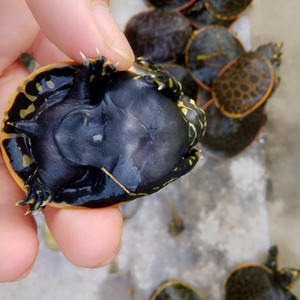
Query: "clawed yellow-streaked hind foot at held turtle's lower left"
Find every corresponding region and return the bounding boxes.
[17,174,52,214]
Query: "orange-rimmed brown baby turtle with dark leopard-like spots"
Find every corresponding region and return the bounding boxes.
[212,43,282,118]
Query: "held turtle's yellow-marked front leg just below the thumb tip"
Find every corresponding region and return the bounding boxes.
[138,57,182,102]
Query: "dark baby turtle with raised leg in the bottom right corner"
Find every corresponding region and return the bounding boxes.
[225,246,300,300]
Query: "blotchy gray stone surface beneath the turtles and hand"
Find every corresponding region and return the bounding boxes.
[0,0,300,300]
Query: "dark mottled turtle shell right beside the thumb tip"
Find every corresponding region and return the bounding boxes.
[125,9,192,65]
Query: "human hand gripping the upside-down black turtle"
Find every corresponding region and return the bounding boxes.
[0,0,134,282]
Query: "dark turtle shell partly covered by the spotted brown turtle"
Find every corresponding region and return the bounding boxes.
[201,100,266,158]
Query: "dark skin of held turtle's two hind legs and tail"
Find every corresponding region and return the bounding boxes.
[11,54,115,213]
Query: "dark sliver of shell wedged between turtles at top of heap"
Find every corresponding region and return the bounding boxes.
[182,1,236,28]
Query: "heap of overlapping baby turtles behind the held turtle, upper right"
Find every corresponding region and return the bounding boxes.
[125,0,282,157]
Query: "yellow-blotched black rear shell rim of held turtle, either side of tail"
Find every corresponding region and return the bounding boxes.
[1,63,82,191]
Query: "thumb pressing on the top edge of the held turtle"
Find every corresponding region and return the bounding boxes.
[26,0,134,69]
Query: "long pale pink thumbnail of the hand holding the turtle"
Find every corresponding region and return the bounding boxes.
[91,1,134,64]
